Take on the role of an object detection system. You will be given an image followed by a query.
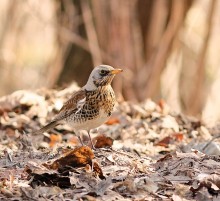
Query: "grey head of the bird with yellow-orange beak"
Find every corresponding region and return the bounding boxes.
[84,65,122,91]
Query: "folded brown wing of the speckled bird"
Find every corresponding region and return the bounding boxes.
[54,90,86,121]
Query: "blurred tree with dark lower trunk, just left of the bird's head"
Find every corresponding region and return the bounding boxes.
[49,0,93,86]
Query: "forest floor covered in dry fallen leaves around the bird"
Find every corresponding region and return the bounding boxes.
[0,85,220,201]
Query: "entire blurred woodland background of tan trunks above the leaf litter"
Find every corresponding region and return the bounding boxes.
[0,0,220,119]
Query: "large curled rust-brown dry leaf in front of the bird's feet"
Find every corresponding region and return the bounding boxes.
[44,146,94,170]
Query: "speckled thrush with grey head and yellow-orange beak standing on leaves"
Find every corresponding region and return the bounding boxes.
[34,64,123,149]
